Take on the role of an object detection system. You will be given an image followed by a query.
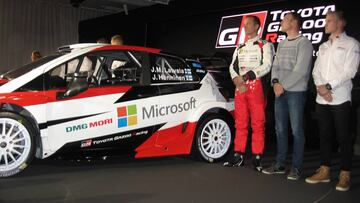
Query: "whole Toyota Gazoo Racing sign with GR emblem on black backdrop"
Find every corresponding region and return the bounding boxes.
[216,5,335,53]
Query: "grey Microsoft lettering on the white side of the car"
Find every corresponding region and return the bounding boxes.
[142,97,196,120]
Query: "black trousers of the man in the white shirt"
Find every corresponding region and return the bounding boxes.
[316,101,353,171]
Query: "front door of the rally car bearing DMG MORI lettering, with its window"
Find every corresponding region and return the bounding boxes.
[46,50,158,155]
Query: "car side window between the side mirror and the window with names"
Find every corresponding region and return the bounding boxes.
[100,50,141,85]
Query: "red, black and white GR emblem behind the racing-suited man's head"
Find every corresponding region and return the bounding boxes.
[216,11,267,48]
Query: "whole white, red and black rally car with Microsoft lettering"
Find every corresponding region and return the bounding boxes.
[0,44,234,177]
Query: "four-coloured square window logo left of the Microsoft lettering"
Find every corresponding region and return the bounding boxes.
[117,104,137,128]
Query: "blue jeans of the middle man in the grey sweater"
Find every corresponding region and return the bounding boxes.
[275,91,306,170]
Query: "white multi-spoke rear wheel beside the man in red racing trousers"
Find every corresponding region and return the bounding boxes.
[196,115,232,162]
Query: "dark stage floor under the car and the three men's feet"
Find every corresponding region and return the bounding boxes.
[0,148,360,203]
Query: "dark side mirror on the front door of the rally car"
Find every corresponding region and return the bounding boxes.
[57,72,89,99]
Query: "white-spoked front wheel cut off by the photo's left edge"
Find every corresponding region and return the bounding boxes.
[0,112,35,177]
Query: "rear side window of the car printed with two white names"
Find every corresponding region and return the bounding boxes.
[150,54,198,83]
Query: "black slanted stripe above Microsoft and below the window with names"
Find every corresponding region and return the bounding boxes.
[115,83,201,104]
